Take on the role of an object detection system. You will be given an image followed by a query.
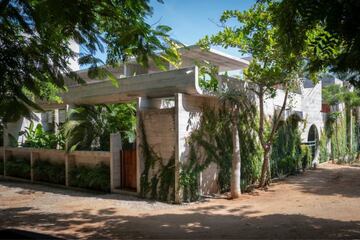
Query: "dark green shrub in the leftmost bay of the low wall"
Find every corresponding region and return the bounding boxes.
[5,156,31,179]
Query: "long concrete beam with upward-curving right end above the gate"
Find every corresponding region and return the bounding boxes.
[62,67,202,104]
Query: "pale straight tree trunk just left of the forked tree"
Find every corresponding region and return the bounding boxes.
[231,110,241,199]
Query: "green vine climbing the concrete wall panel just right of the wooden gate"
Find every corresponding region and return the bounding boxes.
[139,117,175,202]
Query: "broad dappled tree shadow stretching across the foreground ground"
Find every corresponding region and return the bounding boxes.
[0,206,360,239]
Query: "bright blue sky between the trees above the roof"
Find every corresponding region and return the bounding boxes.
[89,0,255,64]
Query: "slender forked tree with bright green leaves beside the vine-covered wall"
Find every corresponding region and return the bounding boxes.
[199,1,304,186]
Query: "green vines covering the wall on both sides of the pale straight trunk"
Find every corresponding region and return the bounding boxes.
[180,104,261,201]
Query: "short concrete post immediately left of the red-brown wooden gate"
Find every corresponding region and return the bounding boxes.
[110,133,122,191]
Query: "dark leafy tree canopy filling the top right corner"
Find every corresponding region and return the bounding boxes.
[270,0,360,86]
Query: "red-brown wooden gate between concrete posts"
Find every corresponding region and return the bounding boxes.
[120,148,136,191]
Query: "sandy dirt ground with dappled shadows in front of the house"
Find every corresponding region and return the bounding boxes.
[0,164,360,239]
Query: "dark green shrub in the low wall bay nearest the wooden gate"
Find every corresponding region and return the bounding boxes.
[69,163,110,192]
